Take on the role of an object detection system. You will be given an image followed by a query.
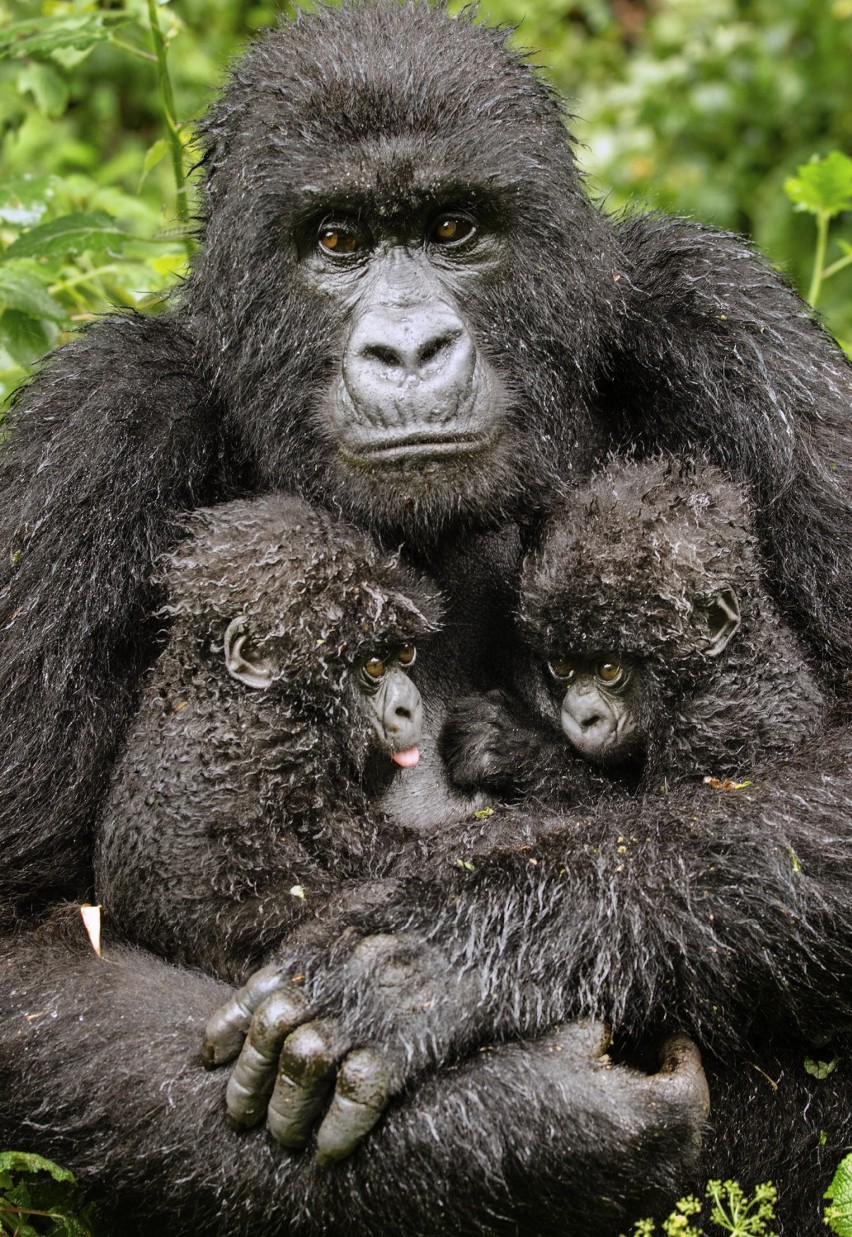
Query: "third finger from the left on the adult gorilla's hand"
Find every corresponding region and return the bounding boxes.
[267,1019,349,1150]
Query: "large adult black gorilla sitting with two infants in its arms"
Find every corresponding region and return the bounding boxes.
[0,4,852,1237]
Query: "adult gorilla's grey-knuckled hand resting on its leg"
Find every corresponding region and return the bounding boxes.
[203,933,481,1163]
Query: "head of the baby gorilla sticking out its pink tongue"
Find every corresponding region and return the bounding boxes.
[163,495,441,769]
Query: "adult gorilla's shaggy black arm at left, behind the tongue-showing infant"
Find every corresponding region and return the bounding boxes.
[0,317,216,913]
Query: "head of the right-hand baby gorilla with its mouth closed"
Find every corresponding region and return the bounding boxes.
[521,459,760,764]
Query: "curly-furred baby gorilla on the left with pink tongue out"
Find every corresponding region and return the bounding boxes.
[96,496,440,980]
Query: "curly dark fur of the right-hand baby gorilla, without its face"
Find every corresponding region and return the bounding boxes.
[519,459,827,785]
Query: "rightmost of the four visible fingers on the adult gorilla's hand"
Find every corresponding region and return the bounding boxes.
[317,1048,391,1165]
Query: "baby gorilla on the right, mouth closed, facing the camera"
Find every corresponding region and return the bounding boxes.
[444,459,826,803]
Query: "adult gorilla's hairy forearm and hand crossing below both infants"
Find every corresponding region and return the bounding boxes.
[207,731,852,1153]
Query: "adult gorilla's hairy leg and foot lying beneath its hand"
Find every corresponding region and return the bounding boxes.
[0,929,705,1237]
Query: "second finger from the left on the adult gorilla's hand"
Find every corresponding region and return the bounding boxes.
[225,988,309,1128]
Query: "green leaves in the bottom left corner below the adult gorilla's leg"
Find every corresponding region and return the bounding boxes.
[0,1152,99,1237]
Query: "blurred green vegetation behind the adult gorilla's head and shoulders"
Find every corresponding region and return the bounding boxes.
[0,0,852,395]
